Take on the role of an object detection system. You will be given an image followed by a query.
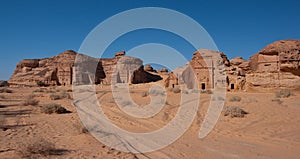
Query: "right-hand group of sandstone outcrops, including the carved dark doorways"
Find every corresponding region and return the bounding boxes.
[174,40,300,90]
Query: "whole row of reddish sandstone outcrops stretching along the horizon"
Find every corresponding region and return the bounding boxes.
[8,40,300,91]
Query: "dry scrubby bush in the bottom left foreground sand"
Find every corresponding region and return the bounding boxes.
[18,138,56,158]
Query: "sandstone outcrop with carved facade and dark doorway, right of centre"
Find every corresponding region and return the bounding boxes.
[174,50,230,90]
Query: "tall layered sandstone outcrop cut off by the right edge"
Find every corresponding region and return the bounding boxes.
[246,40,300,88]
